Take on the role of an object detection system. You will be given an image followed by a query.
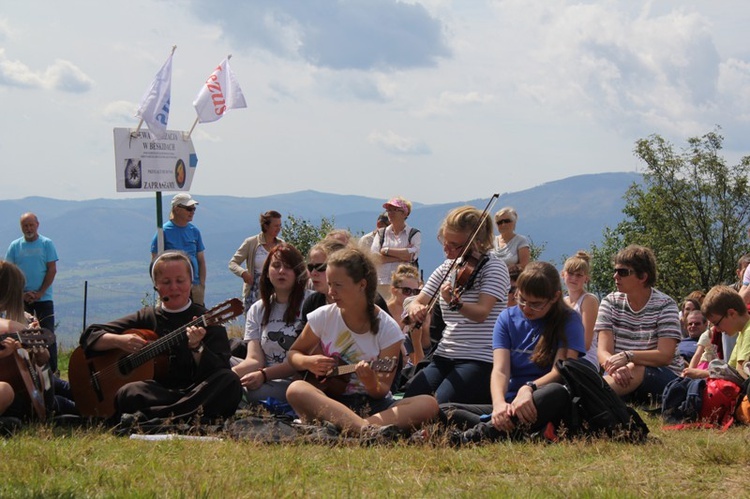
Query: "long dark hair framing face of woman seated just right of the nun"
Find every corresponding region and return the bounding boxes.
[260,243,307,326]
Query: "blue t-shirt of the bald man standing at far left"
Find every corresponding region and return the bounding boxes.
[5,234,58,301]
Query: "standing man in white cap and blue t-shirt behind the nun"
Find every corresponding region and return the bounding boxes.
[151,192,206,305]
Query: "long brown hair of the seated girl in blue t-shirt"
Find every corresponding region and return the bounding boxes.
[516,261,573,367]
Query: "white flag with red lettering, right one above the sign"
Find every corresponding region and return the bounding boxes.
[193,58,247,123]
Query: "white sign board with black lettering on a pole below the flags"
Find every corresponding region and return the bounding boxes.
[114,128,198,192]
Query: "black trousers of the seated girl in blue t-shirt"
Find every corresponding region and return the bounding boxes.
[440,383,572,433]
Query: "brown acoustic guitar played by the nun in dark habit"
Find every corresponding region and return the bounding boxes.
[68,298,244,418]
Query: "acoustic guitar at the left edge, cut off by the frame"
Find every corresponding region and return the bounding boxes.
[0,328,55,421]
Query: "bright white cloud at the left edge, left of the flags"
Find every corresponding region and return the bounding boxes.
[0,48,94,93]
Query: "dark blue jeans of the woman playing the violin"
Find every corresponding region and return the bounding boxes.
[404,355,492,404]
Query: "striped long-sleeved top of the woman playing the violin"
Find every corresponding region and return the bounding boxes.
[422,255,510,363]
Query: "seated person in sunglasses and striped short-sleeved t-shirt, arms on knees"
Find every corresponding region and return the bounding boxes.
[594,245,684,403]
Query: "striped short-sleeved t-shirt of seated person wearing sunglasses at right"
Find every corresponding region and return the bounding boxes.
[594,288,684,375]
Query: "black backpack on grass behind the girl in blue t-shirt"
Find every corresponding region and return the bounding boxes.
[555,359,648,442]
